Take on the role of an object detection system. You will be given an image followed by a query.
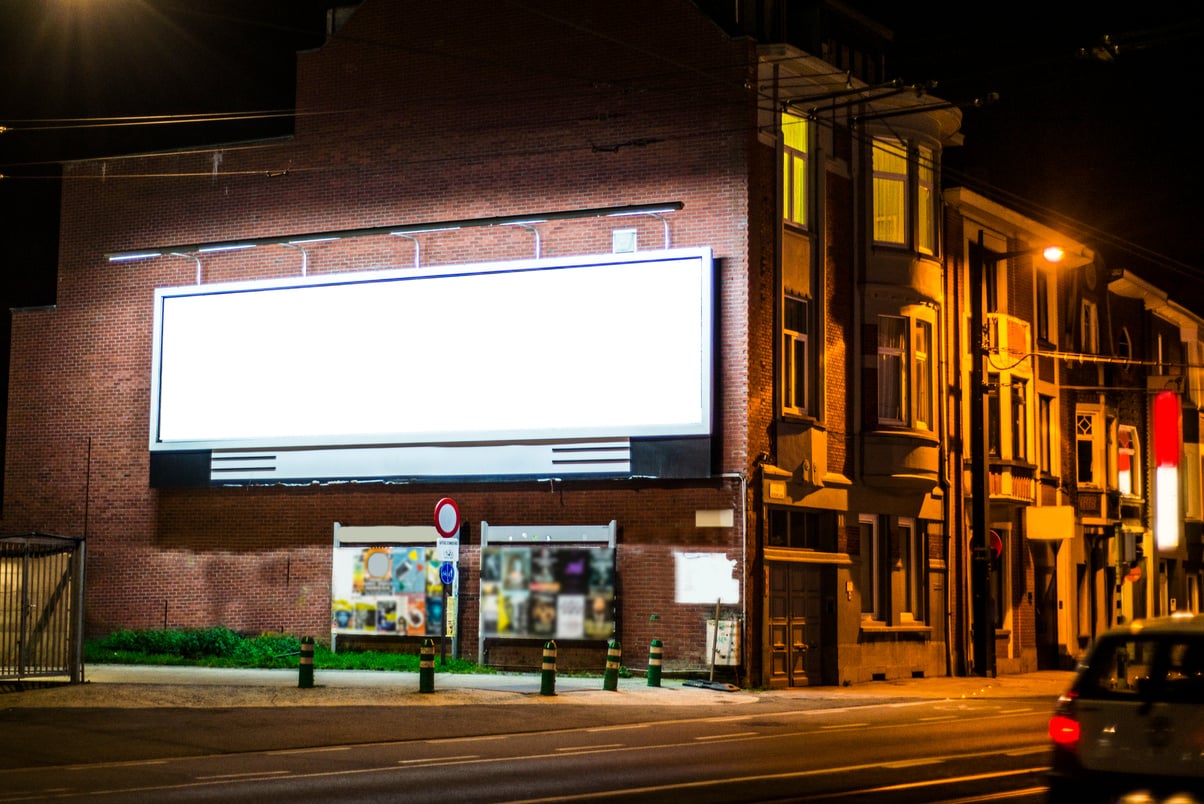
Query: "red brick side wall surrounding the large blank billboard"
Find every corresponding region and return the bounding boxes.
[0,0,768,667]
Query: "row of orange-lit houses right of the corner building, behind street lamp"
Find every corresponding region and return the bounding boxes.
[945,188,1202,674]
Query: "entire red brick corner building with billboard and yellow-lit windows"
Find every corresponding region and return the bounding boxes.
[2,0,960,685]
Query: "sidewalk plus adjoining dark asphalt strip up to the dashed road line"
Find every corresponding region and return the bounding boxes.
[0,664,1070,770]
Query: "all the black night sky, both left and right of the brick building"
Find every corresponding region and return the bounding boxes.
[0,0,1204,312]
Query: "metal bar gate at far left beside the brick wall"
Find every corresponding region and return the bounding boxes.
[0,533,84,684]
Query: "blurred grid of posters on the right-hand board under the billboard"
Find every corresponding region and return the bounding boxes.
[480,545,614,639]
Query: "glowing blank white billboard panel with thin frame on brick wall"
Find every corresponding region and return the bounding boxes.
[151,249,713,450]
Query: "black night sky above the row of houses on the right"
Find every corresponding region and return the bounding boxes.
[867,0,1204,304]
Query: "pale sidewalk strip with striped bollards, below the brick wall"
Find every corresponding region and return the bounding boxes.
[0,664,1073,708]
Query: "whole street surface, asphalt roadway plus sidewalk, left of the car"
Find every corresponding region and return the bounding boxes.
[0,672,1066,804]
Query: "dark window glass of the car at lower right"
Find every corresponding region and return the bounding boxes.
[1076,634,1204,703]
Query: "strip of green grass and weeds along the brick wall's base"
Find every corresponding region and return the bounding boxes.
[83,627,497,673]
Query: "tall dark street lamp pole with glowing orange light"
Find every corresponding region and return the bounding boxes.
[968,229,1063,678]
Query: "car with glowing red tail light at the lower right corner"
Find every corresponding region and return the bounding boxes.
[1049,615,1204,802]
